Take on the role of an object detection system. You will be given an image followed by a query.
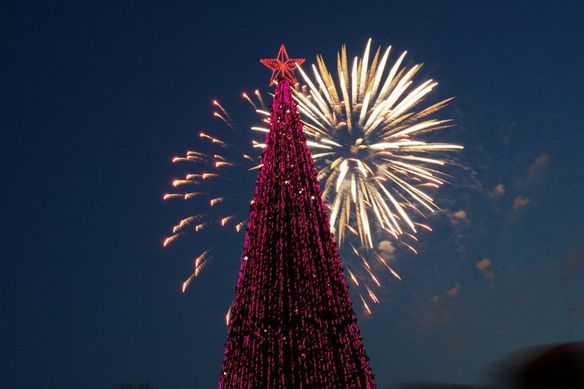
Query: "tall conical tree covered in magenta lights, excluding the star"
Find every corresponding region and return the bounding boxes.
[219,80,375,389]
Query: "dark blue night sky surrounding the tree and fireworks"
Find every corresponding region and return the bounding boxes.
[0,1,584,389]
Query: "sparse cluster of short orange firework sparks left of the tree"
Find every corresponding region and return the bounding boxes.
[162,97,259,292]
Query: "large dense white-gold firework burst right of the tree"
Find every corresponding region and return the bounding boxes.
[296,40,462,248]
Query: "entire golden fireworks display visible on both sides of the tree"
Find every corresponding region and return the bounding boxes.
[164,40,462,312]
